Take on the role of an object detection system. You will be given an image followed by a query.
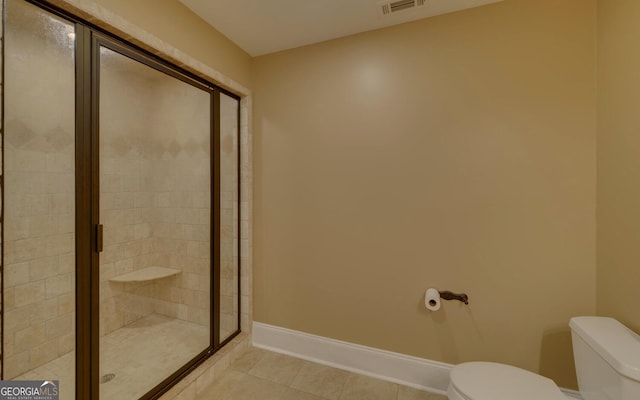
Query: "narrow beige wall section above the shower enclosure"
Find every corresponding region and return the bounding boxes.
[95,0,251,86]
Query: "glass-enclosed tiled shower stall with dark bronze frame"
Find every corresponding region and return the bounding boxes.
[0,0,240,400]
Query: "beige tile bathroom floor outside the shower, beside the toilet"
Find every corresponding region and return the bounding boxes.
[196,348,447,400]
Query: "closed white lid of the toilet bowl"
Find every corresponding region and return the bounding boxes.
[451,361,567,400]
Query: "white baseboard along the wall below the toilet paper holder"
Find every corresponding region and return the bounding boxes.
[253,322,582,399]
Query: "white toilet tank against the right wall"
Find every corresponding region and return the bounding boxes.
[569,317,640,400]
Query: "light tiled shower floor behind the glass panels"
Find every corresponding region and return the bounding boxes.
[13,314,209,400]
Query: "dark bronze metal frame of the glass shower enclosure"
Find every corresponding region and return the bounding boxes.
[0,0,241,400]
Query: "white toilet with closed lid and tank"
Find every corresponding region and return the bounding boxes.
[447,317,640,400]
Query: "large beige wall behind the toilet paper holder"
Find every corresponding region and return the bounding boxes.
[252,0,596,387]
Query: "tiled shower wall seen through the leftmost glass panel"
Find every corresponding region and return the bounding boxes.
[3,8,75,379]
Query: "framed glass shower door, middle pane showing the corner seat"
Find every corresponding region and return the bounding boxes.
[99,43,212,399]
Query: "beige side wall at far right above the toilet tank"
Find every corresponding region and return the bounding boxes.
[597,0,640,332]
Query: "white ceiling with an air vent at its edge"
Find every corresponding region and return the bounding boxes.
[180,0,502,56]
